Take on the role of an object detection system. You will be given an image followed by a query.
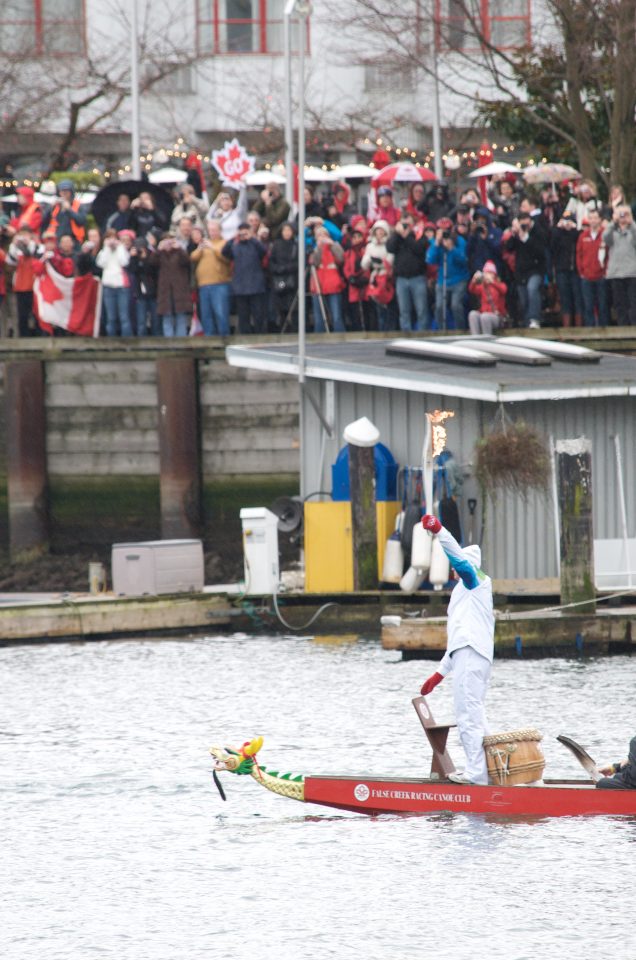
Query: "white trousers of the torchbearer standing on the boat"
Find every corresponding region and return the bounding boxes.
[451,647,492,783]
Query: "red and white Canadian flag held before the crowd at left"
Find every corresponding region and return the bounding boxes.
[33,263,102,337]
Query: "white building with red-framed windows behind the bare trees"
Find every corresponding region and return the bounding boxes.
[0,0,541,165]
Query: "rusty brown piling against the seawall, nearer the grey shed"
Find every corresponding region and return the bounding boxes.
[157,357,203,540]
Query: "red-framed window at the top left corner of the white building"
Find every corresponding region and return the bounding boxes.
[0,0,86,57]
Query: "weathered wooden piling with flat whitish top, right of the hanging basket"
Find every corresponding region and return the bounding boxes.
[556,437,596,613]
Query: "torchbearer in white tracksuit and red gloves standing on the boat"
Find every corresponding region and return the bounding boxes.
[421,514,495,784]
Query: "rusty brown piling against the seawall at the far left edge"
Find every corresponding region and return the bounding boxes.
[5,360,49,563]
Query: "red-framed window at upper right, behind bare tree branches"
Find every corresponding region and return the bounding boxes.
[435,0,531,52]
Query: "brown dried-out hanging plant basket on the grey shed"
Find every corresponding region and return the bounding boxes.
[475,411,550,497]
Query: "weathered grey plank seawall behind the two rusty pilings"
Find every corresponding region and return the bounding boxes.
[0,338,299,480]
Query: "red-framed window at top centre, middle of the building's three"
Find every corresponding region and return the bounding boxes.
[196,0,309,56]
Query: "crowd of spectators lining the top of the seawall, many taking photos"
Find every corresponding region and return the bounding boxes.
[0,169,636,337]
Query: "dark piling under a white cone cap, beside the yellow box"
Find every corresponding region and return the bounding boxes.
[348,443,378,590]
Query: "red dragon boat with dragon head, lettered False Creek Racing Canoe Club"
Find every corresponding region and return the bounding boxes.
[210,697,636,818]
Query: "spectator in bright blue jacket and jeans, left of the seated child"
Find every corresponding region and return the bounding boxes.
[426,218,470,330]
